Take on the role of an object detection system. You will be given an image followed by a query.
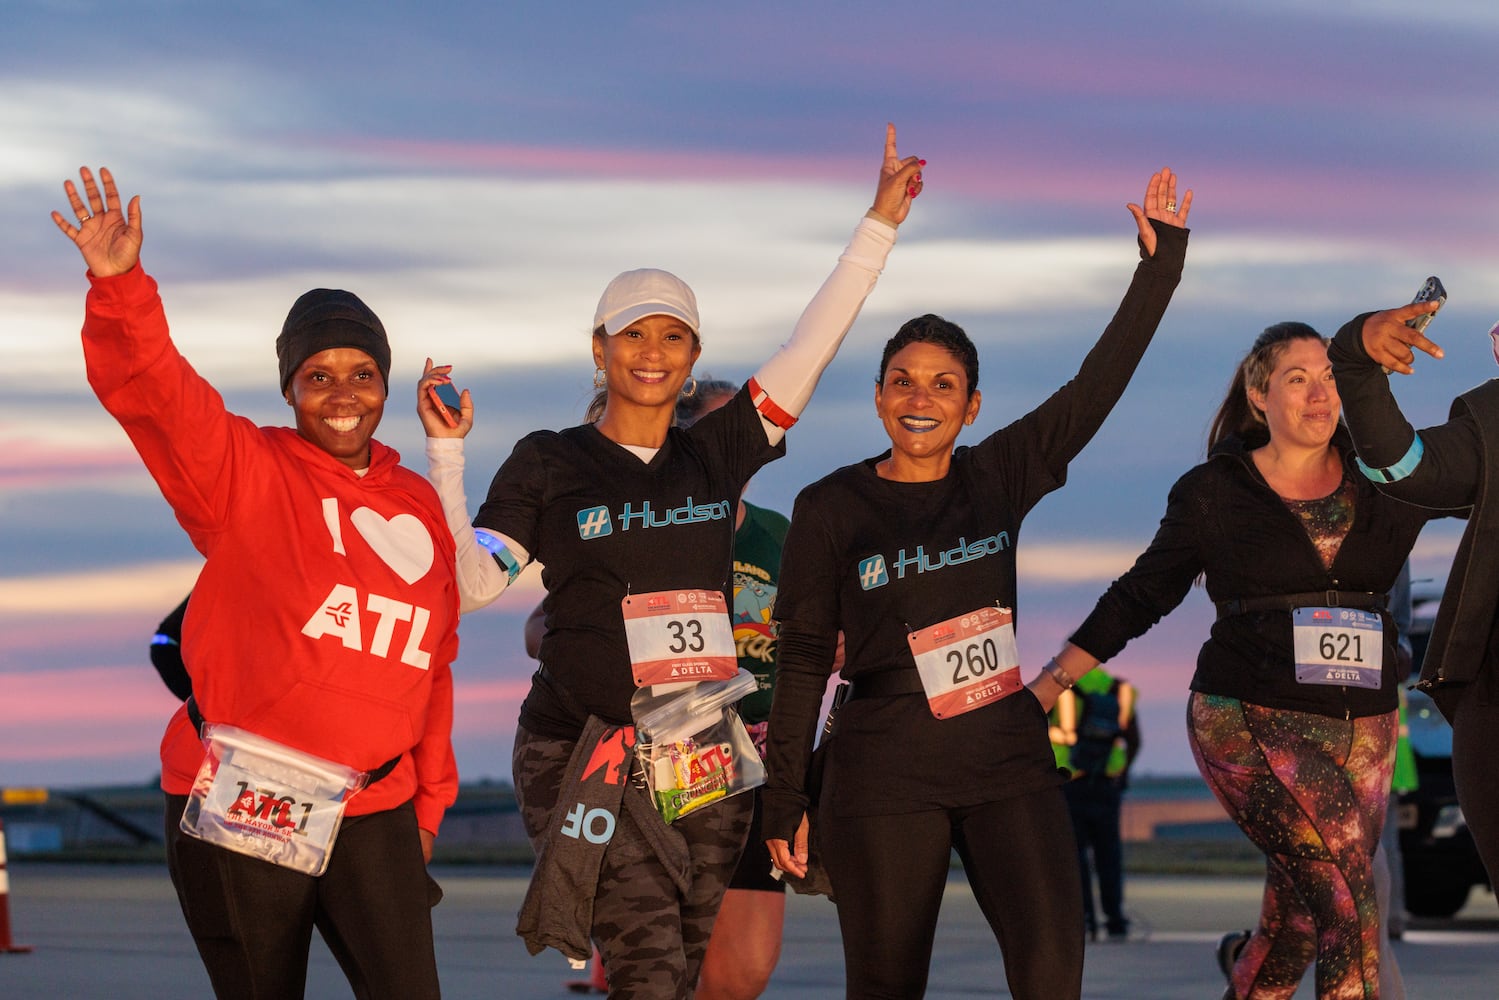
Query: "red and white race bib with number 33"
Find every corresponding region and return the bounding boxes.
[621,591,739,688]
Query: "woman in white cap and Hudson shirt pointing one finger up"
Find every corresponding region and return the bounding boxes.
[418,126,922,997]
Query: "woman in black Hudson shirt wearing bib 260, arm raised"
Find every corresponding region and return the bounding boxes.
[761,171,1192,1000]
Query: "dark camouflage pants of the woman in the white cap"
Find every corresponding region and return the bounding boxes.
[511,727,752,1000]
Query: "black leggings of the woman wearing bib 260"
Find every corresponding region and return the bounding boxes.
[818,787,1082,1000]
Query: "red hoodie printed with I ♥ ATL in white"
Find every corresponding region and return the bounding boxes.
[82,265,459,834]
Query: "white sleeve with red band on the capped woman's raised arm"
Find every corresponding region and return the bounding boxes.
[754,216,895,444]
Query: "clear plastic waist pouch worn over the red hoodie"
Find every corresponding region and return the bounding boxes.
[181,723,369,876]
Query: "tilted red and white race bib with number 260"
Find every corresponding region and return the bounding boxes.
[907,607,1024,718]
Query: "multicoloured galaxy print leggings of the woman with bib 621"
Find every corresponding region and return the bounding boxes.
[1187,693,1397,1000]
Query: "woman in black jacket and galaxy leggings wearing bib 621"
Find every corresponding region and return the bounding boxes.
[1033,322,1441,1000]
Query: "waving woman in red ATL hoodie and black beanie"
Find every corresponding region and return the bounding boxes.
[52,168,459,999]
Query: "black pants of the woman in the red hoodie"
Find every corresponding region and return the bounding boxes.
[166,795,441,1000]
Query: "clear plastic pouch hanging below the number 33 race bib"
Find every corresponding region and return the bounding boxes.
[630,670,764,823]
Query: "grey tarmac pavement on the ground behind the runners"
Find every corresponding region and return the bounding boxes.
[0,861,1499,1000]
